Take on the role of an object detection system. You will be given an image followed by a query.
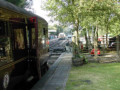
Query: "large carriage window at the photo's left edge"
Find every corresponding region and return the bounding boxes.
[0,21,12,66]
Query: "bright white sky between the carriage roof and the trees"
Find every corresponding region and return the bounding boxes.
[32,0,54,25]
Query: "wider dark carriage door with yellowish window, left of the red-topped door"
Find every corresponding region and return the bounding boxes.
[11,18,28,75]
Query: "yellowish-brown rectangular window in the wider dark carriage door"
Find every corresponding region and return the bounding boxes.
[14,29,25,49]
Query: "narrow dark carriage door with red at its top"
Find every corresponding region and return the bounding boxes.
[28,17,38,76]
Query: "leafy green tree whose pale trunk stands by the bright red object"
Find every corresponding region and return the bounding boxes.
[82,0,116,58]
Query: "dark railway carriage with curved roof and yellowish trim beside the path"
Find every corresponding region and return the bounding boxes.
[0,0,49,89]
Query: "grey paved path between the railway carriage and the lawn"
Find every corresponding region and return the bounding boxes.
[32,53,72,90]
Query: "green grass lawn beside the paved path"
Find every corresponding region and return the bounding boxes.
[66,63,120,90]
